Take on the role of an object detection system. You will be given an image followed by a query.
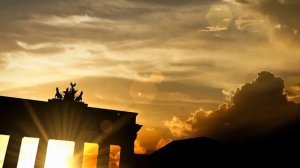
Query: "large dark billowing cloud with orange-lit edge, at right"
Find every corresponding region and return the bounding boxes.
[165,71,300,139]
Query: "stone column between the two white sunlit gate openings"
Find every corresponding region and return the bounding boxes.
[34,138,48,168]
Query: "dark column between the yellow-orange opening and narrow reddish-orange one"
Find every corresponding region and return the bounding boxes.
[97,144,110,168]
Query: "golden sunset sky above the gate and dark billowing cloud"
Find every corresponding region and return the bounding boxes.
[0,0,300,153]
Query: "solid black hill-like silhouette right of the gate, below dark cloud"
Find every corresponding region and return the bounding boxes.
[135,120,300,168]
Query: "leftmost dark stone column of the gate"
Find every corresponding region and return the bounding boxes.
[3,135,22,167]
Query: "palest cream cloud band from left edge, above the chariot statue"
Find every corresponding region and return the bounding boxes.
[0,41,149,89]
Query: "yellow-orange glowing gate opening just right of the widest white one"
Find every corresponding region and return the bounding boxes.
[82,143,98,168]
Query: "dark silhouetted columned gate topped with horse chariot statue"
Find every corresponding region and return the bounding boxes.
[0,83,141,168]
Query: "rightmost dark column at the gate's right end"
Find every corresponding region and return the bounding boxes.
[120,140,135,168]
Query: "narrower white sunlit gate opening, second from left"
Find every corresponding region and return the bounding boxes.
[18,137,39,168]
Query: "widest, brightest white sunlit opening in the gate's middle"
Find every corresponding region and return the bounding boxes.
[45,140,75,168]
